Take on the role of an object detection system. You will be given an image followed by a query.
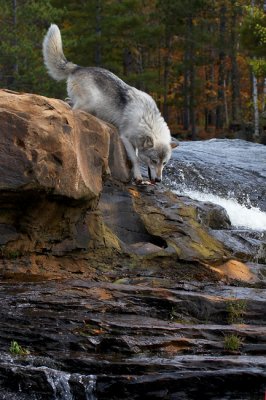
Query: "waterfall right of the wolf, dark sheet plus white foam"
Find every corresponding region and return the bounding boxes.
[165,139,266,231]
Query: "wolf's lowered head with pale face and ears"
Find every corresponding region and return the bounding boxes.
[138,136,178,182]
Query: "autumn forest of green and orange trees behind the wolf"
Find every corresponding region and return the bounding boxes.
[0,0,266,143]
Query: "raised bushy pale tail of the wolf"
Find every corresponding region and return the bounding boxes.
[43,24,77,81]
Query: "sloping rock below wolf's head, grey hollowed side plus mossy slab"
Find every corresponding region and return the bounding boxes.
[99,183,229,261]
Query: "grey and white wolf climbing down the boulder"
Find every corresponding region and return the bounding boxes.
[43,24,176,183]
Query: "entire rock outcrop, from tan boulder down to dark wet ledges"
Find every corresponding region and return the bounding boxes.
[0,90,266,400]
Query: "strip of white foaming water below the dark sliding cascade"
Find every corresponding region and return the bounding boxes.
[175,189,266,231]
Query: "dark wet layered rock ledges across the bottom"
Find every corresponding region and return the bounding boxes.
[0,282,266,400]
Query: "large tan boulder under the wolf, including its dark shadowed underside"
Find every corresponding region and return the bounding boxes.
[0,90,129,255]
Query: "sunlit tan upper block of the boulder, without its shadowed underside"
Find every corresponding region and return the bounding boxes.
[0,90,128,200]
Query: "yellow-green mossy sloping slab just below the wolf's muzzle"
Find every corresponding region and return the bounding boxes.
[133,188,228,261]
